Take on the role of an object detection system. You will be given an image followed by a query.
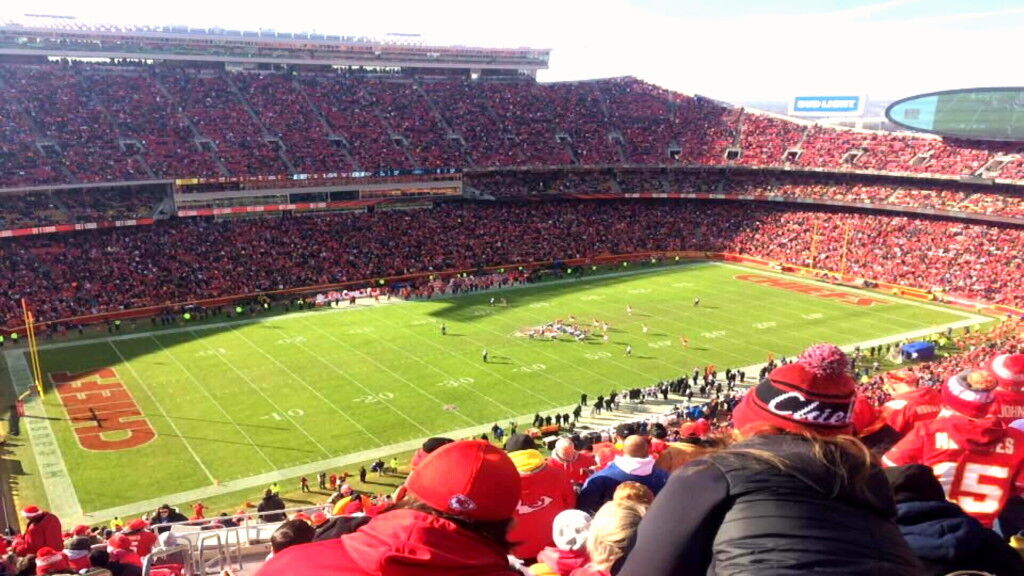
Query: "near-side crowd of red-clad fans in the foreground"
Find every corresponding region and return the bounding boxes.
[8,338,1024,576]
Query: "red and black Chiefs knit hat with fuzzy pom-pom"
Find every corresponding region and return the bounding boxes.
[732,344,856,436]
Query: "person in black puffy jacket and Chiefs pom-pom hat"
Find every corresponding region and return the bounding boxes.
[620,344,920,576]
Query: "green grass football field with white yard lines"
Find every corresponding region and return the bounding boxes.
[6,263,991,518]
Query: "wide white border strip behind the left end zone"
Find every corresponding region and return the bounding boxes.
[4,351,82,518]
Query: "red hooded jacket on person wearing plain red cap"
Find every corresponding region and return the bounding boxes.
[256,509,516,576]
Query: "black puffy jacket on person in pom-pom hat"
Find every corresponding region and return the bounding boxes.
[618,435,920,576]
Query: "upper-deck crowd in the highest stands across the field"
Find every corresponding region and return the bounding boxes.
[6,61,1024,186]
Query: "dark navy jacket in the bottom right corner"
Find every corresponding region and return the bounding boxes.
[896,500,1024,576]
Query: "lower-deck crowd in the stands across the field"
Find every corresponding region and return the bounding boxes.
[0,201,1024,327]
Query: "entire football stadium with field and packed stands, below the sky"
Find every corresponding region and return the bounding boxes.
[0,4,1024,576]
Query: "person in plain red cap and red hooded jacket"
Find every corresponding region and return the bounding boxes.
[257,441,520,576]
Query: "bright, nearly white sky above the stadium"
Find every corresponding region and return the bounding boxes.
[0,0,1024,102]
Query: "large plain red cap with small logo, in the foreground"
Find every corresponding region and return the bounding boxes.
[406,440,520,522]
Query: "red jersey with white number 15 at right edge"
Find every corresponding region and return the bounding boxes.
[883,410,1024,528]
